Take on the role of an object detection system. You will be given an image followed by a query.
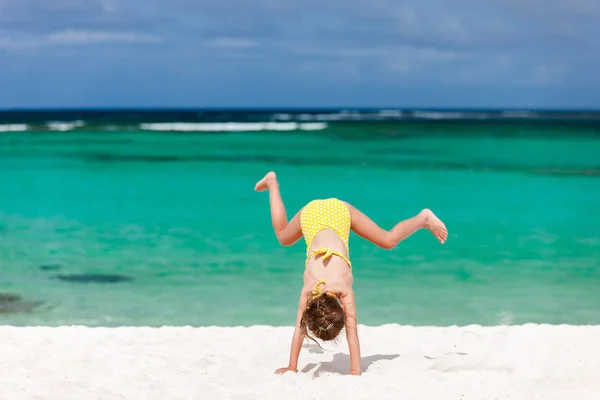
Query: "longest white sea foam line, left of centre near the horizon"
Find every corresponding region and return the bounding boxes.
[140,122,327,132]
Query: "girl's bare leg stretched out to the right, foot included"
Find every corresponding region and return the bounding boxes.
[345,203,448,250]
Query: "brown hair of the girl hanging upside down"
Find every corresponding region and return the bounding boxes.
[300,292,346,344]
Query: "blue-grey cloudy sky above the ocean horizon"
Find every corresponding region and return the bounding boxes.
[0,0,600,109]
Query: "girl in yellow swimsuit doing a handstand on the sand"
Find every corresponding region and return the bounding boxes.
[254,172,448,375]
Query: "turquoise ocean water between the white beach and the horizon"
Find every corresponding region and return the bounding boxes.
[0,110,600,326]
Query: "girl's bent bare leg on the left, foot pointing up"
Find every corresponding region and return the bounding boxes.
[254,172,302,246]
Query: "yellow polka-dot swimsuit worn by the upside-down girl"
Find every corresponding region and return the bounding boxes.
[300,198,352,268]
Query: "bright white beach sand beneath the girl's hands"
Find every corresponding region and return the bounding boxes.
[0,325,600,400]
